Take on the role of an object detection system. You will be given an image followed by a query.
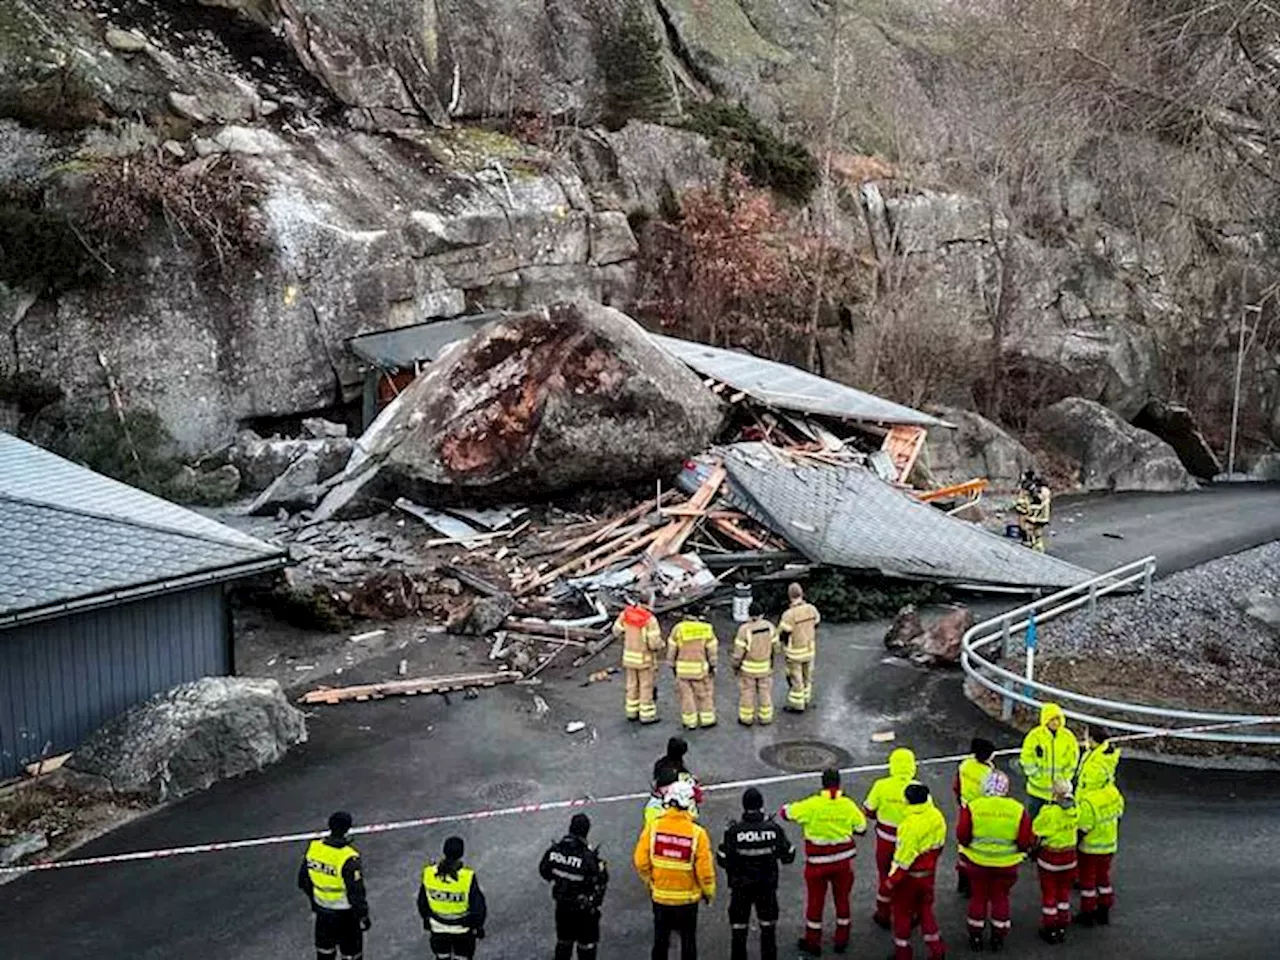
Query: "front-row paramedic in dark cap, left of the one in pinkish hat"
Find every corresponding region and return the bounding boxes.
[886,783,947,960]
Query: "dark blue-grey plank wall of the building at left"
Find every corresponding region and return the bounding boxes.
[0,585,232,777]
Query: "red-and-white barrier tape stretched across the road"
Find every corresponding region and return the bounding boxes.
[0,717,1280,877]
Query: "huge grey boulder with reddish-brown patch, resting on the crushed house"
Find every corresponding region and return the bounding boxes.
[319,303,721,516]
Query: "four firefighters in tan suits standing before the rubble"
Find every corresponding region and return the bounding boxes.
[613,584,822,730]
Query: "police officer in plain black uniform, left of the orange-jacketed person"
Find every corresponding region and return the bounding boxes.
[538,813,609,960]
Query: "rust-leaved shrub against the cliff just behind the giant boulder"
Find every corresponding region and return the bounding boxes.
[637,172,868,364]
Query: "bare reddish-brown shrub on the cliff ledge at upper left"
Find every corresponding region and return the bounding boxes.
[84,151,265,268]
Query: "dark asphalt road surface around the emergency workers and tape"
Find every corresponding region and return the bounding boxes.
[0,489,1280,960]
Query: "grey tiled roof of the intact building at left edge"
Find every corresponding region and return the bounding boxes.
[0,433,284,626]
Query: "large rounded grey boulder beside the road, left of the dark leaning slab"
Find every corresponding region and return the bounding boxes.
[1034,397,1196,492]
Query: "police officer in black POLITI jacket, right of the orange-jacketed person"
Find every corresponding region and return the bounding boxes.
[716,787,796,960]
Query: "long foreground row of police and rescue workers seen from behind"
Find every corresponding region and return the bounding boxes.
[298,704,1124,960]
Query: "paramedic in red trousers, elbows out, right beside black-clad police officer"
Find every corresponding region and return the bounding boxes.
[778,769,867,956]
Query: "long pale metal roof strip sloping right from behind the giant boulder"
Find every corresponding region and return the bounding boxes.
[653,334,947,426]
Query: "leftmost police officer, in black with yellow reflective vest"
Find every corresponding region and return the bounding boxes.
[298,810,370,960]
